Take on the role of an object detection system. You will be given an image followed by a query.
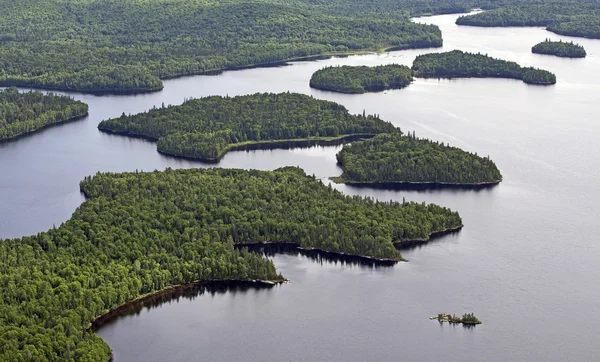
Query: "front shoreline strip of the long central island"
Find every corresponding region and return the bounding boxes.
[98,127,376,164]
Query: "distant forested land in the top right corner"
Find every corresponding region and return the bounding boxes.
[456,0,600,39]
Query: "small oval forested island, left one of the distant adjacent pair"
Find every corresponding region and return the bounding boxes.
[310,64,413,93]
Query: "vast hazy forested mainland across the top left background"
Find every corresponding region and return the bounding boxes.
[0,0,454,93]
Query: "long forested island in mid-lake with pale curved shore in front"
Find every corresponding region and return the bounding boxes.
[98,93,398,161]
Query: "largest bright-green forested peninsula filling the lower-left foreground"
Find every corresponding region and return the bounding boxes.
[0,167,462,361]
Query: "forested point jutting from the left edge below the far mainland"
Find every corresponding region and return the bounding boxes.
[0,87,88,141]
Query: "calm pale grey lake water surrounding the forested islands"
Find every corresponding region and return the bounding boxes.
[0,15,600,362]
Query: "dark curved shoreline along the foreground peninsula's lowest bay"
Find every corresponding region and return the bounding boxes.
[87,279,287,332]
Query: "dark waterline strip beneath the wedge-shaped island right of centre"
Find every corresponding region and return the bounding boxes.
[329,176,502,190]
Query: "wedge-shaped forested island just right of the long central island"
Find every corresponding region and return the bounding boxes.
[334,133,502,185]
